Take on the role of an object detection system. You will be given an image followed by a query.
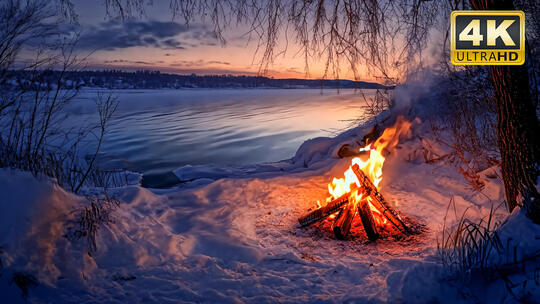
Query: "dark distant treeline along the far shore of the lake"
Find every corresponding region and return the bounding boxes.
[2,70,393,89]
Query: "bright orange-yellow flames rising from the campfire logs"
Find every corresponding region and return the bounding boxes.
[327,116,412,225]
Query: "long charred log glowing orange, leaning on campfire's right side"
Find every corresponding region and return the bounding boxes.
[352,164,411,233]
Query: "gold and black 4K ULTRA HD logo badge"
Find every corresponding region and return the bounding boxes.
[450,11,525,65]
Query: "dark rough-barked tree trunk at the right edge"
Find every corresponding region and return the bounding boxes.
[470,0,540,223]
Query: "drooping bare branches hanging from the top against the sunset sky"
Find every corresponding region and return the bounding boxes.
[71,0,441,84]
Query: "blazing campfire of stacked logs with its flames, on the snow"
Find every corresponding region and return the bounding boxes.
[298,117,411,241]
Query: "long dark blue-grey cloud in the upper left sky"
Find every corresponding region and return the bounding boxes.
[78,21,216,50]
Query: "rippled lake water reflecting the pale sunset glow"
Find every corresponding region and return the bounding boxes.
[72,89,374,174]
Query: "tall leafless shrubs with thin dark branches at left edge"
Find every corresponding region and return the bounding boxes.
[0,0,121,192]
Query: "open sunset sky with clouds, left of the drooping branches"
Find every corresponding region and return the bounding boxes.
[68,0,366,79]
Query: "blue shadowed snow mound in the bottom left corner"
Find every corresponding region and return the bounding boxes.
[0,169,83,303]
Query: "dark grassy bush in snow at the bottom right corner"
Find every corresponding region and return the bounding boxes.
[437,200,540,303]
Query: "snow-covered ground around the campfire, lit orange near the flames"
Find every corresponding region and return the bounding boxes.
[0,82,540,303]
